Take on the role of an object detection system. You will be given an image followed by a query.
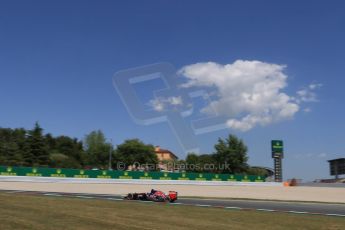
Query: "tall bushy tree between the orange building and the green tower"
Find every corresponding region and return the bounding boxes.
[214,135,248,173]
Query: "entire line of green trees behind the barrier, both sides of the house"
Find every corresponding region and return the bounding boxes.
[0,123,263,175]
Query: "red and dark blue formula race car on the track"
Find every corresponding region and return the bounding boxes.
[124,189,177,203]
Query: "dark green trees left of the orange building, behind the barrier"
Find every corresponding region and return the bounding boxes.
[0,123,158,169]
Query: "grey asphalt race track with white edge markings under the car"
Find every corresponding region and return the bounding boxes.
[0,190,345,217]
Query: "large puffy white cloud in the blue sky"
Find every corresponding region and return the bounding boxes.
[179,60,300,131]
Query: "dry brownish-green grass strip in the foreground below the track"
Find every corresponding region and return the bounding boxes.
[0,193,345,230]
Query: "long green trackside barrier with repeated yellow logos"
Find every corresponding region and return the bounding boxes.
[0,166,265,182]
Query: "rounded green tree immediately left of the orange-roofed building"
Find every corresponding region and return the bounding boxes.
[116,139,158,168]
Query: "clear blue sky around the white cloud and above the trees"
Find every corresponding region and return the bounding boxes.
[0,0,345,179]
